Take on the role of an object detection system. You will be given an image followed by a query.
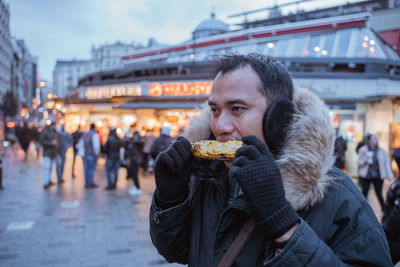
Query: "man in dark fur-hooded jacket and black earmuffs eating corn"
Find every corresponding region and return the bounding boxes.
[150,54,391,266]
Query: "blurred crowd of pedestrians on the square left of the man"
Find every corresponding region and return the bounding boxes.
[5,121,178,198]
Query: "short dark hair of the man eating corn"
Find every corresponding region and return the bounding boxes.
[211,53,293,103]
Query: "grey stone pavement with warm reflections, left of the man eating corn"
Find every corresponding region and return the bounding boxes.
[0,150,182,267]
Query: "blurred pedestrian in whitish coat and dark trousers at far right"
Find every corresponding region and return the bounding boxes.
[357,135,393,210]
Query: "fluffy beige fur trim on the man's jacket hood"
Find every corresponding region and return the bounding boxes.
[183,89,335,210]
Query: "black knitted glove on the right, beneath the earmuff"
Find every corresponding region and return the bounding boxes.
[229,135,299,239]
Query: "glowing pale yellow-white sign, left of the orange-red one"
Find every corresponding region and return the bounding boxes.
[85,85,142,99]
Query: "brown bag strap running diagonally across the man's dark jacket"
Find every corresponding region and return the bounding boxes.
[218,217,255,267]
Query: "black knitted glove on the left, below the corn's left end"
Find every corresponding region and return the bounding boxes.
[154,136,192,209]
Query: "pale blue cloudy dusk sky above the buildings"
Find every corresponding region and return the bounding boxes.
[5,0,359,82]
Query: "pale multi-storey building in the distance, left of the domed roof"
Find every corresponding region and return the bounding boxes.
[53,42,141,97]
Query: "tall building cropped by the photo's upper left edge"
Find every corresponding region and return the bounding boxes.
[0,1,12,96]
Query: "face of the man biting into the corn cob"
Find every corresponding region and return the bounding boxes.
[209,66,267,168]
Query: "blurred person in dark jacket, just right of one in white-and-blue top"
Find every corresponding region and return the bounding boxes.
[104,126,122,190]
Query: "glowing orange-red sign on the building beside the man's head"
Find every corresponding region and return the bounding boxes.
[149,82,212,96]
